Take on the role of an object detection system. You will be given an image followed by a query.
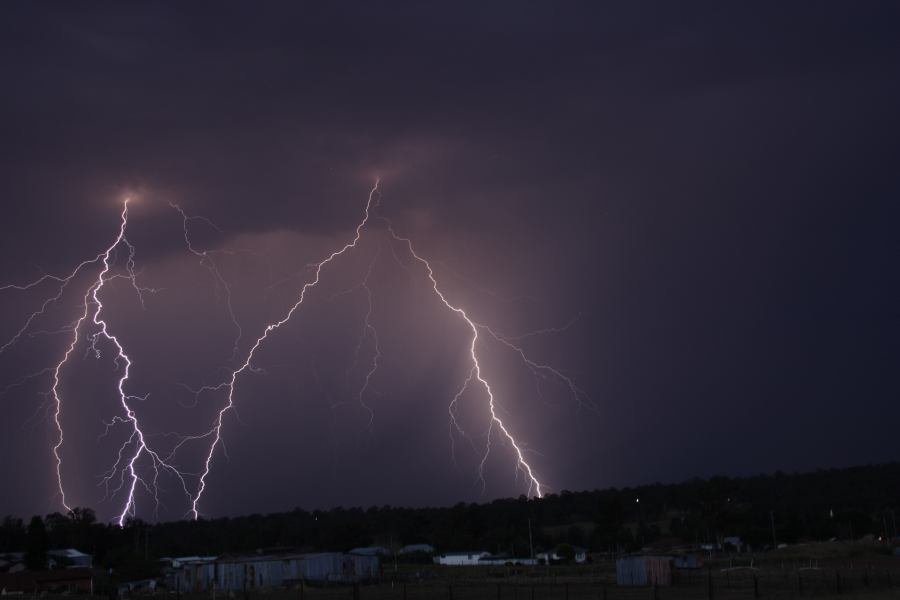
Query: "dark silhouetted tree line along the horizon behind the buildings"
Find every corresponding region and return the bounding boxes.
[0,463,900,578]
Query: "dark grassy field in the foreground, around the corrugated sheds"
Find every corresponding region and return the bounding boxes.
[28,543,900,600]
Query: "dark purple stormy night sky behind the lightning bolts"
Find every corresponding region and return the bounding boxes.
[0,1,900,519]
